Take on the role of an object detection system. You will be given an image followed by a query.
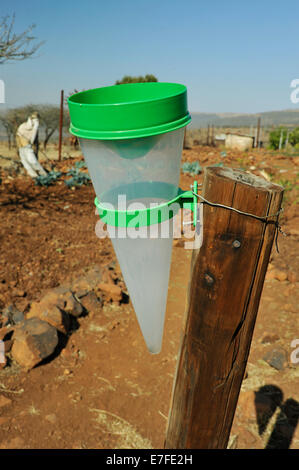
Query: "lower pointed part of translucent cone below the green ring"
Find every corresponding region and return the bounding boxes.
[108,221,173,354]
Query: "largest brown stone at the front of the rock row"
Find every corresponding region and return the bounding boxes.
[11,318,58,370]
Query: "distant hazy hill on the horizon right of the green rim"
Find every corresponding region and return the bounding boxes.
[189,109,299,129]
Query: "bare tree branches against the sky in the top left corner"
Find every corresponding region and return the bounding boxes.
[0,14,44,64]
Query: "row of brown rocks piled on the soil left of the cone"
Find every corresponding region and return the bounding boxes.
[0,265,126,370]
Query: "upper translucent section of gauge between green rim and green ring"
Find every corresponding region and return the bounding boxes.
[80,128,184,205]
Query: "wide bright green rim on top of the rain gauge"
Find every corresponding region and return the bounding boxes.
[68,82,191,140]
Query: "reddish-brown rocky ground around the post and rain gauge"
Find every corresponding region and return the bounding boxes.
[0,142,299,449]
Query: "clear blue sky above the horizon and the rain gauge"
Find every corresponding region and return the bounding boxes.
[0,0,299,113]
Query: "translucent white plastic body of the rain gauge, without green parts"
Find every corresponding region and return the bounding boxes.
[80,128,184,353]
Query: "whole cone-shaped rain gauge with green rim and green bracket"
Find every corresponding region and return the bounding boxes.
[68,82,197,353]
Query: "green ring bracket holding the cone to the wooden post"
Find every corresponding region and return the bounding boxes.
[95,181,198,228]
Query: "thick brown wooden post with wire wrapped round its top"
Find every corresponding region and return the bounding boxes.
[165,167,283,449]
